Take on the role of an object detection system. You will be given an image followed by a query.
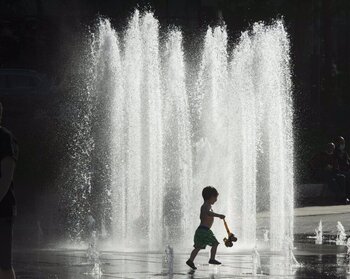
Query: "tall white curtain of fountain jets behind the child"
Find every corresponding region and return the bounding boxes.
[67,10,293,251]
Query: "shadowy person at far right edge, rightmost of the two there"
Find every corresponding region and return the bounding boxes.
[334,136,350,198]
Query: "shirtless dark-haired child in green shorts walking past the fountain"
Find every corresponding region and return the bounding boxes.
[186,186,225,269]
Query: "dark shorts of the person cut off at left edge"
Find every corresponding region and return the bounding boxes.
[0,218,13,270]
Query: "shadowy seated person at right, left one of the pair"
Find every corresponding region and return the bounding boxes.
[310,142,346,203]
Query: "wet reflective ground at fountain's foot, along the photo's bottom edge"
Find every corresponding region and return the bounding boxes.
[14,246,350,279]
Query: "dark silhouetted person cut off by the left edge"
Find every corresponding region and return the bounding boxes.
[0,103,18,279]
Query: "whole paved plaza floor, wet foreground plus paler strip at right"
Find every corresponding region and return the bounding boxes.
[14,206,350,279]
